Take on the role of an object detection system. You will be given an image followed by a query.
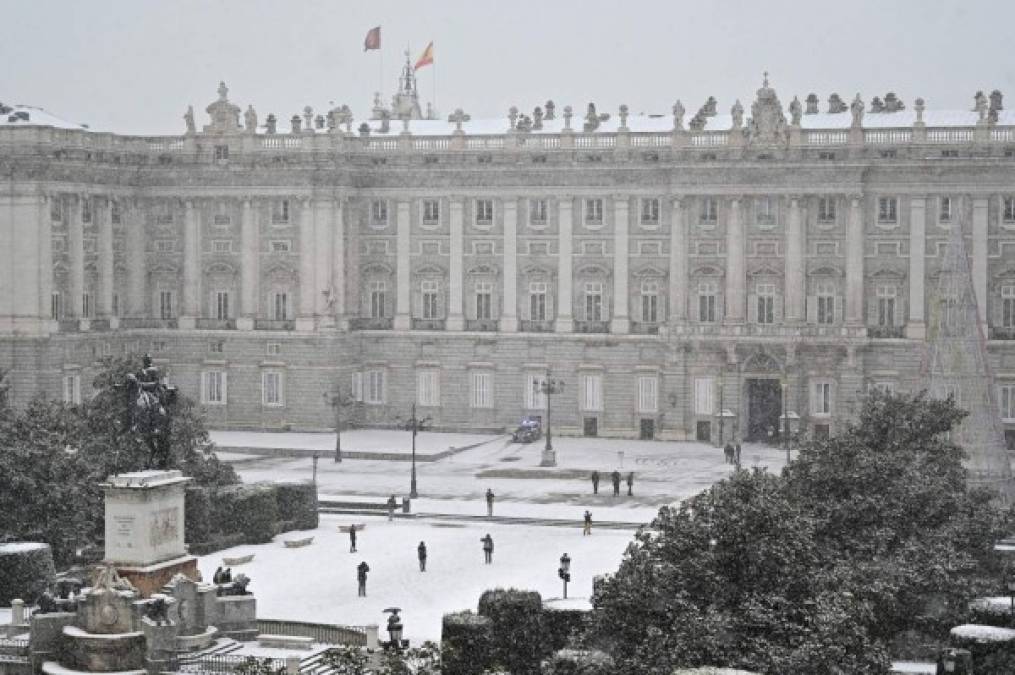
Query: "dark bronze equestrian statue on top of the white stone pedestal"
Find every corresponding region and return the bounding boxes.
[126,354,177,469]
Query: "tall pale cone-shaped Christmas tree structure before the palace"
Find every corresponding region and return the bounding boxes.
[926,222,1012,495]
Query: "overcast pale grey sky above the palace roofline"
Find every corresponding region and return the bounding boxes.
[0,0,1015,134]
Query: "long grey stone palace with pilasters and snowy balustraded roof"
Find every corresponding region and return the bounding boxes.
[0,72,1015,442]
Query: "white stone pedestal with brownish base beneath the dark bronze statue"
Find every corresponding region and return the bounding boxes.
[102,471,197,598]
